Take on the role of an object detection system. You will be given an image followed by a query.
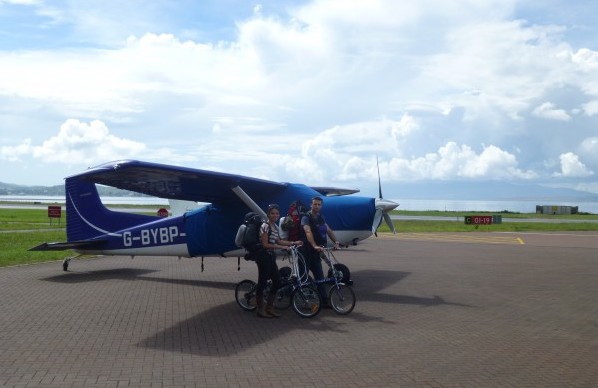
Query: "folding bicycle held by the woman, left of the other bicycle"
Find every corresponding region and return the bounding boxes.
[235,246,322,318]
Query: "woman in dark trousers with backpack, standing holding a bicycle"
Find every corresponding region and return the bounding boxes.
[255,204,302,318]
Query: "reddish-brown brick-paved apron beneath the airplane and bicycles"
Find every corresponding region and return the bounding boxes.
[0,232,598,387]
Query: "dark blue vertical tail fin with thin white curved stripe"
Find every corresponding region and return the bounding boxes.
[65,177,159,242]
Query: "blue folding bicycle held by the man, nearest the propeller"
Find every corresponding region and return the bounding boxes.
[312,247,356,315]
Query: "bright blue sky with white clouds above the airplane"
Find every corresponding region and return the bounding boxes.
[0,0,598,197]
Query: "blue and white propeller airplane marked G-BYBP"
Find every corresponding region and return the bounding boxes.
[30,160,398,271]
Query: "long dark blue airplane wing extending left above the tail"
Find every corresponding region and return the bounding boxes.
[69,160,286,204]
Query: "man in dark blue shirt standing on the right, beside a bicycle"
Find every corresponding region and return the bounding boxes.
[301,197,339,307]
